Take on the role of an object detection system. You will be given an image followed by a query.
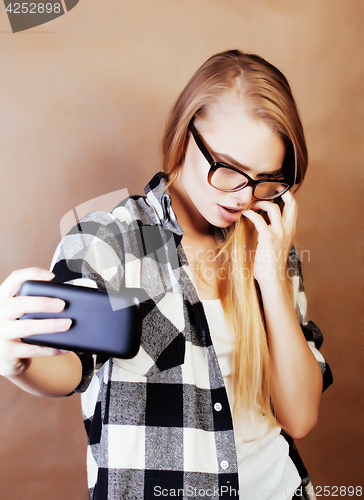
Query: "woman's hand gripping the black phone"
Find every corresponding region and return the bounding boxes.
[0,268,71,377]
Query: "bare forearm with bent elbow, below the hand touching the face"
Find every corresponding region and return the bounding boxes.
[261,280,322,439]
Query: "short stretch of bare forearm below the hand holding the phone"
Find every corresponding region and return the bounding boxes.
[8,352,82,398]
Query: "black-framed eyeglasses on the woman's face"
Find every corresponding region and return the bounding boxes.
[189,122,292,200]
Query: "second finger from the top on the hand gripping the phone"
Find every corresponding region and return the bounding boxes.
[0,295,66,320]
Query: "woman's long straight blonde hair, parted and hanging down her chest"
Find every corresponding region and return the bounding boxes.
[162,50,308,427]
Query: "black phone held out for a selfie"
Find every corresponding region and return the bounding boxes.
[19,281,143,359]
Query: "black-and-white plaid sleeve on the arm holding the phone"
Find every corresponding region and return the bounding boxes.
[51,212,124,394]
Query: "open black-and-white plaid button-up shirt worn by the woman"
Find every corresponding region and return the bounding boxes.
[52,173,332,500]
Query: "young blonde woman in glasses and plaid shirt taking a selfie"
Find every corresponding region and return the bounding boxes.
[0,51,331,500]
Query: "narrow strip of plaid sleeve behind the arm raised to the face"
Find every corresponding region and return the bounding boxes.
[288,246,333,391]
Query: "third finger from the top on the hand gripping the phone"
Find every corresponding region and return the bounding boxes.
[3,318,72,340]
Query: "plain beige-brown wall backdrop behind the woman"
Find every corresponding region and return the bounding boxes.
[0,0,364,500]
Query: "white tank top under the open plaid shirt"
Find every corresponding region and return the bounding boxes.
[202,299,301,500]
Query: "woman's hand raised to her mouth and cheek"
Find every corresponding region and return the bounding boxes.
[242,191,298,287]
